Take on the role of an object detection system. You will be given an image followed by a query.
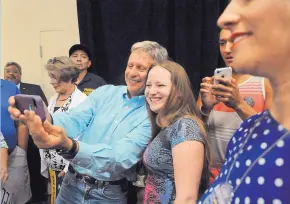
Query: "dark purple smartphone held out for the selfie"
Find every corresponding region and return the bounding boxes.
[14,94,46,122]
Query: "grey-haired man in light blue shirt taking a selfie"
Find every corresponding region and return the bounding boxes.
[9,41,168,204]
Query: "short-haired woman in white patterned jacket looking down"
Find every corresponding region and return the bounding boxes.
[40,57,87,203]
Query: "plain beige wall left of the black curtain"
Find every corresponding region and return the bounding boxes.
[0,0,79,90]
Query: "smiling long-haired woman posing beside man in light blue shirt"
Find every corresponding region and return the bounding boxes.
[143,61,209,204]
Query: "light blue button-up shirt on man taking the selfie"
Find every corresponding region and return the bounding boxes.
[53,85,151,181]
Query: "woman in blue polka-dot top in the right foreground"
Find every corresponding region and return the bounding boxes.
[199,0,290,204]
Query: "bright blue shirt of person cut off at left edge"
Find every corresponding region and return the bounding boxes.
[0,79,20,152]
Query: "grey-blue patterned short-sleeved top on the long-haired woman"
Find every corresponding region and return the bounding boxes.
[143,118,204,204]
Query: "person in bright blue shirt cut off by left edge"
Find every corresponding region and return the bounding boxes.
[0,79,31,204]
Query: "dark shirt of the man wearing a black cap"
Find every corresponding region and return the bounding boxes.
[77,72,107,95]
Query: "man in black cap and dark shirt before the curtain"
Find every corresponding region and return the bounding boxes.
[69,44,106,95]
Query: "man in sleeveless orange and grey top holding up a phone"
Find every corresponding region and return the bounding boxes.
[197,30,273,182]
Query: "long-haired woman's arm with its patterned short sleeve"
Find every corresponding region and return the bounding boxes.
[168,118,206,204]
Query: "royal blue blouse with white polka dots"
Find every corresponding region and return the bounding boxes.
[198,111,290,204]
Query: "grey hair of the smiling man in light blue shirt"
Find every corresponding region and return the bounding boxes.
[131,41,168,62]
